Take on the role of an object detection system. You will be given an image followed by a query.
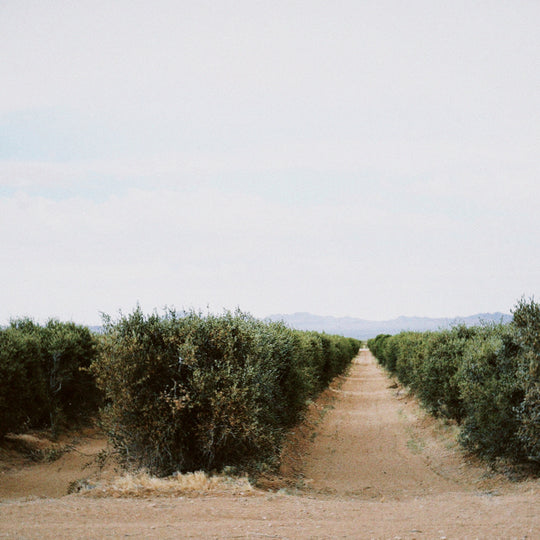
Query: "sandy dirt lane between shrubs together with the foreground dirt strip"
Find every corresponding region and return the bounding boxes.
[0,351,540,539]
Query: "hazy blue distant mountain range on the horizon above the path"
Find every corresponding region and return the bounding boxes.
[267,313,512,339]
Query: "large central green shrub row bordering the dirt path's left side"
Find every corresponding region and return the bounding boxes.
[92,309,359,475]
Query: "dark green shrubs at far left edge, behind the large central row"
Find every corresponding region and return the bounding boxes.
[0,319,99,437]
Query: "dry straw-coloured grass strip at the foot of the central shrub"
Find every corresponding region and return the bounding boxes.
[80,471,253,497]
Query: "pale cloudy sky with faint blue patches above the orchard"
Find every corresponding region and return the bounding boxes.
[0,0,540,325]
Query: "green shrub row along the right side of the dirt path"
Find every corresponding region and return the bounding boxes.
[368,300,540,466]
